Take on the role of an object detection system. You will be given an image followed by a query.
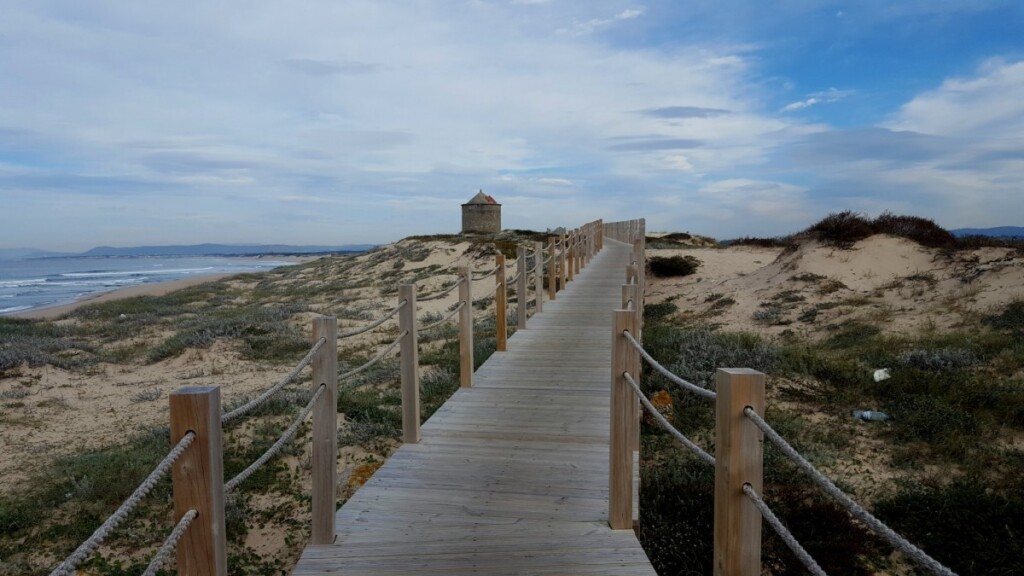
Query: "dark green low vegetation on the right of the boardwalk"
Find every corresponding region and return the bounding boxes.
[640,300,1024,575]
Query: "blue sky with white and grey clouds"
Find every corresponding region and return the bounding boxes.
[0,0,1024,250]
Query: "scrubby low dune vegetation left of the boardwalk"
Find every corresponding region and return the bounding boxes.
[0,230,515,575]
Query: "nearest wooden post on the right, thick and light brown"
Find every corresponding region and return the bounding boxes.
[715,368,765,576]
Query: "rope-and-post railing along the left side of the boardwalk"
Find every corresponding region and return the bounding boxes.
[44,228,589,576]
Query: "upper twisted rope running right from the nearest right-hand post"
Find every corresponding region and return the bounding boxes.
[743,407,956,576]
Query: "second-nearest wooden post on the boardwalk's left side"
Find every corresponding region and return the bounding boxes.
[311,316,338,544]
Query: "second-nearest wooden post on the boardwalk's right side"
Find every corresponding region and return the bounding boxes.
[608,310,639,530]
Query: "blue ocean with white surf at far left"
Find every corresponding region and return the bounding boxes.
[0,256,295,316]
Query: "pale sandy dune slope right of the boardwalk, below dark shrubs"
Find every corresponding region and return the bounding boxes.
[648,236,1024,338]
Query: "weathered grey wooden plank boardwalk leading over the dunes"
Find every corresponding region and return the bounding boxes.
[293,240,654,575]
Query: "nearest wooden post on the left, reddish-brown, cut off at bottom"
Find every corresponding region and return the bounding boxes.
[170,386,227,576]
